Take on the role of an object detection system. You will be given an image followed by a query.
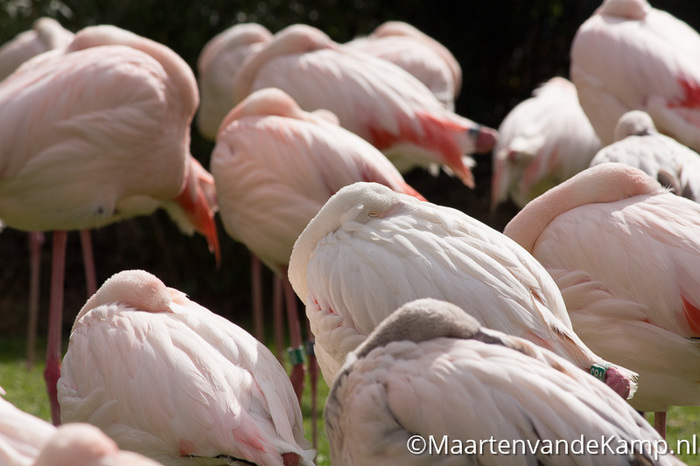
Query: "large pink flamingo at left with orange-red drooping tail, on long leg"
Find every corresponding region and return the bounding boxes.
[0,26,219,423]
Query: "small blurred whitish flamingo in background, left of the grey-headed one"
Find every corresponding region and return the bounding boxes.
[491,76,600,211]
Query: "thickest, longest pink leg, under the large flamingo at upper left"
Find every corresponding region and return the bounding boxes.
[44,231,67,426]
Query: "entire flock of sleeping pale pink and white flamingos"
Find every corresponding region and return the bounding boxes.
[0,0,700,465]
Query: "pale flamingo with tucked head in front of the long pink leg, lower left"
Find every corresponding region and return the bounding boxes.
[58,270,315,465]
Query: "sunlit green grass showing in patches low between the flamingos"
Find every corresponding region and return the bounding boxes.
[0,338,700,466]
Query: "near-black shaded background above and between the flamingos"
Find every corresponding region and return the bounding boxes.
[0,0,700,336]
